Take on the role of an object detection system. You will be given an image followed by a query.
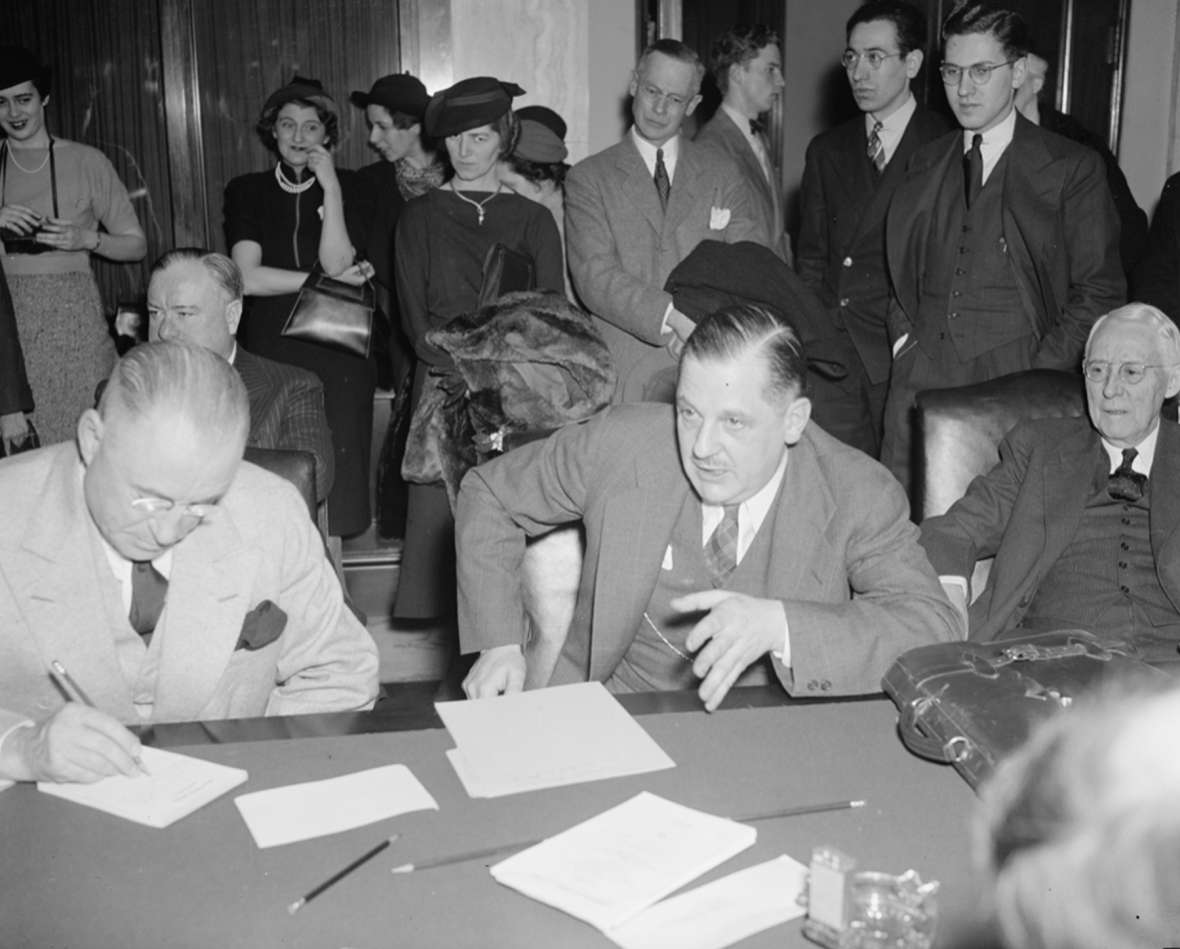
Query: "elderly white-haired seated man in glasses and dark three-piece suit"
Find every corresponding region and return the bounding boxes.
[922,303,1180,656]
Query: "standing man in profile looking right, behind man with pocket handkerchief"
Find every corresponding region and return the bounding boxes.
[696,24,791,263]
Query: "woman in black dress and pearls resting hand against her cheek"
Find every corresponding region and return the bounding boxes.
[225,76,375,537]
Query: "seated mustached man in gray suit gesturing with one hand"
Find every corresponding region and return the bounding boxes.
[457,306,964,711]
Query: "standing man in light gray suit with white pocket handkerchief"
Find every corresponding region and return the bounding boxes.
[565,39,769,400]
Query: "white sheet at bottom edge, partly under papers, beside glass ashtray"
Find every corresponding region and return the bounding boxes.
[607,856,807,949]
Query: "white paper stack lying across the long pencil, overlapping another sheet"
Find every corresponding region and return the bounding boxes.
[491,791,758,930]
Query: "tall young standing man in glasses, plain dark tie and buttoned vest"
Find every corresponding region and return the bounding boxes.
[881,2,1126,487]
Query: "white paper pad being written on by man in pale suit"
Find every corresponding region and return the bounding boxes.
[37,746,247,827]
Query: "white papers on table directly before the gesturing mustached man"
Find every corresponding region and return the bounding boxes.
[435,682,676,798]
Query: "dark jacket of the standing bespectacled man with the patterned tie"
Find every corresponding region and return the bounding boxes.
[795,106,950,385]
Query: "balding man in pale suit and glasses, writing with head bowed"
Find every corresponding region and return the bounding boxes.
[0,342,378,781]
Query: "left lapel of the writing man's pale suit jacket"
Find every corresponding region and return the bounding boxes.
[13,441,136,721]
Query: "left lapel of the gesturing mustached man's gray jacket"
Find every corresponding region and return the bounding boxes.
[589,434,690,679]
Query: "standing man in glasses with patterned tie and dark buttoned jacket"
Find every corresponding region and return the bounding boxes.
[795,0,950,456]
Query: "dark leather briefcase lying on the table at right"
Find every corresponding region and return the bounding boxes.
[881,629,1180,787]
